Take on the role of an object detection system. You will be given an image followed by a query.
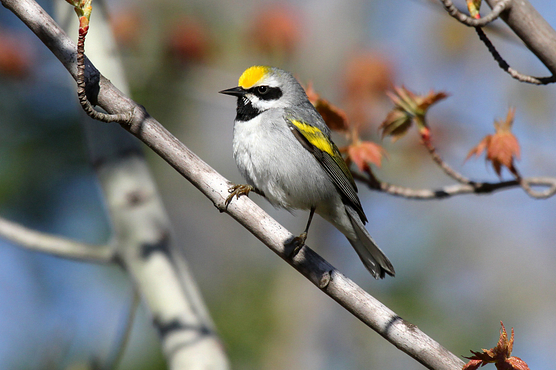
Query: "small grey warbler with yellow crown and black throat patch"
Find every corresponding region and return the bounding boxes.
[220,66,395,279]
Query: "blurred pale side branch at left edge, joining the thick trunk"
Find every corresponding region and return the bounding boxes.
[0,217,116,263]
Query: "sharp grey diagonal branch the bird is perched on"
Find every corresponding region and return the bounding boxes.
[1,0,463,370]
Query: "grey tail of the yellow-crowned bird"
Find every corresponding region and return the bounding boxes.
[346,205,396,279]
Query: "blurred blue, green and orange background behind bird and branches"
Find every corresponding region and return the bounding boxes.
[0,0,556,370]
